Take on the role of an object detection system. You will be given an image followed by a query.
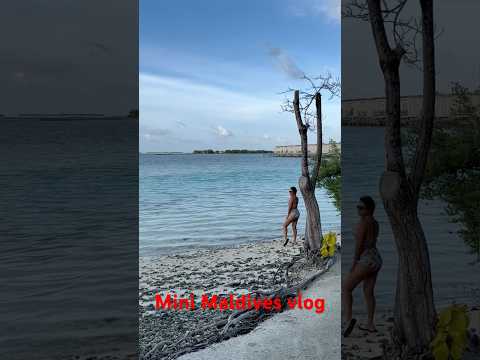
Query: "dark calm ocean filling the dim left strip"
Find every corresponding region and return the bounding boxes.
[0,118,138,360]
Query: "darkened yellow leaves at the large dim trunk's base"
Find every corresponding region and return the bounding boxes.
[431,305,469,360]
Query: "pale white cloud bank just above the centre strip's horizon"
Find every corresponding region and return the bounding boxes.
[140,73,340,151]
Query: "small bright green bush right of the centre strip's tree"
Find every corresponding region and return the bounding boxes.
[317,140,342,211]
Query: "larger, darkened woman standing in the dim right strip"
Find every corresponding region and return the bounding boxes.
[342,196,382,337]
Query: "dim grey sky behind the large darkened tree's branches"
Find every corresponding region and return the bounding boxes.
[342,0,480,99]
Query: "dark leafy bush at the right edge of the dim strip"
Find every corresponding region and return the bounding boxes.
[416,83,480,261]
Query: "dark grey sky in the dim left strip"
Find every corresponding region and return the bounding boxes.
[0,0,138,115]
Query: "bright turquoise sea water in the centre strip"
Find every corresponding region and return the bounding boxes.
[139,154,340,255]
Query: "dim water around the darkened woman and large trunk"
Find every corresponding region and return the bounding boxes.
[342,127,480,311]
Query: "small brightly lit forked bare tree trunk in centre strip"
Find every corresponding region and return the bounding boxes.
[293,90,322,253]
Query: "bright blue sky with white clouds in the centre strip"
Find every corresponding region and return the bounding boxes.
[140,0,341,152]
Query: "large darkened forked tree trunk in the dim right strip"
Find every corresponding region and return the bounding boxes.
[368,0,436,358]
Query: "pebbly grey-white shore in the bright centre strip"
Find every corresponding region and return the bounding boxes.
[139,239,338,359]
